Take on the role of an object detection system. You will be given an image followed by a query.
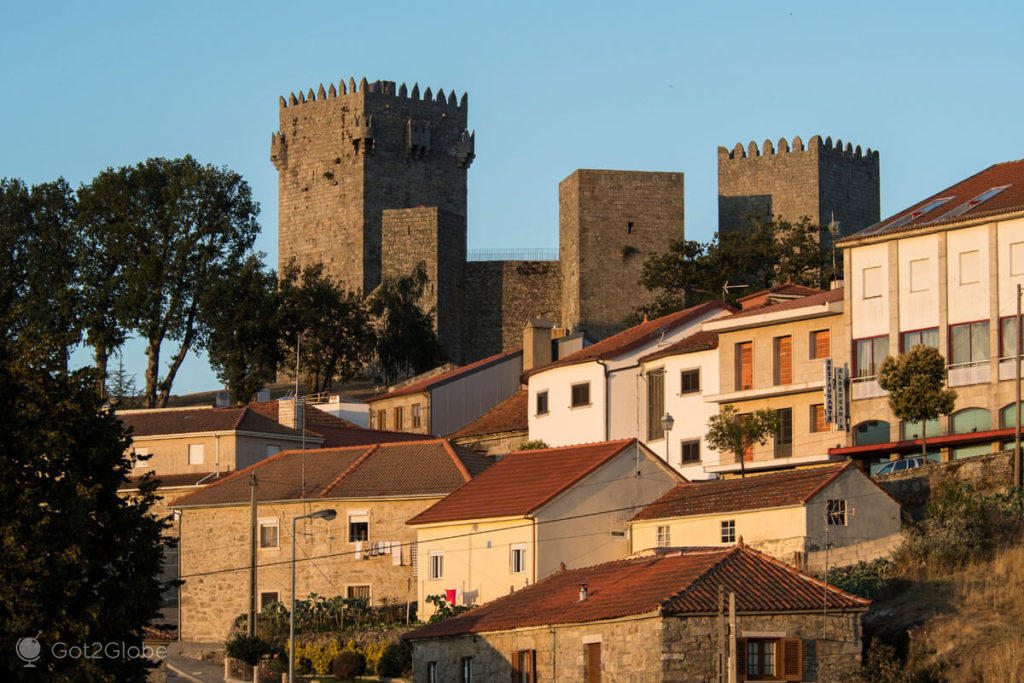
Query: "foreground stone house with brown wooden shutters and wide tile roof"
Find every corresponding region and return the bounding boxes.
[406,544,869,683]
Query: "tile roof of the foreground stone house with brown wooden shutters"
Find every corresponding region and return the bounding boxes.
[406,545,870,640]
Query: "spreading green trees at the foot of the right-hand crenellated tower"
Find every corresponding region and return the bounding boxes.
[627,216,836,324]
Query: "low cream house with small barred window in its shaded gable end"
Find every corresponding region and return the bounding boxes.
[630,463,900,566]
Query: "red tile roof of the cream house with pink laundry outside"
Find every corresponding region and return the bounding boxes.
[408,439,637,524]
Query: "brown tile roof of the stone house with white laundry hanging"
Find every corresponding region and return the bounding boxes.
[173,439,492,507]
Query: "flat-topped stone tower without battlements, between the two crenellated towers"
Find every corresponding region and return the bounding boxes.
[558,169,683,339]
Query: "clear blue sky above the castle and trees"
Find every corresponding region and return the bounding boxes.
[0,0,1024,393]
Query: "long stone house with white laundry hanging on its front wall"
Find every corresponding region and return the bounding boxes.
[172,439,490,642]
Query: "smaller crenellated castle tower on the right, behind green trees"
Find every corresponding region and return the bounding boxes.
[718,135,881,239]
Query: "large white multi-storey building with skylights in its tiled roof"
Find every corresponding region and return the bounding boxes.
[834,161,1024,470]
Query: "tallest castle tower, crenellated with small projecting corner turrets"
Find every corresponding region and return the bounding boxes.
[270,79,474,292]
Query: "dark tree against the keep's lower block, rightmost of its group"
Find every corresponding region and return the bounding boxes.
[369,262,444,383]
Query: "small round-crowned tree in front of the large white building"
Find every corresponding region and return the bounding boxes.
[879,344,956,456]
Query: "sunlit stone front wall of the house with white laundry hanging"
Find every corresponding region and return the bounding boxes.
[178,497,439,642]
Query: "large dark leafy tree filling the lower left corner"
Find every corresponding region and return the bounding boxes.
[0,352,168,681]
